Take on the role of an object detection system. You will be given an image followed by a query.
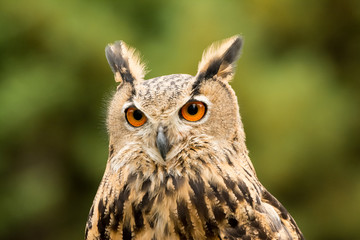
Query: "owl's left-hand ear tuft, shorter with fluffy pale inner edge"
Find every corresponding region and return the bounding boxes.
[105,41,146,83]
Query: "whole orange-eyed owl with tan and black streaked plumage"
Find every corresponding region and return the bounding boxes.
[85,36,304,240]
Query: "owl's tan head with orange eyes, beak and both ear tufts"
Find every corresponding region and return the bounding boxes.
[105,36,246,173]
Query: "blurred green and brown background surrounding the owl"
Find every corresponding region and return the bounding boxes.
[0,0,360,240]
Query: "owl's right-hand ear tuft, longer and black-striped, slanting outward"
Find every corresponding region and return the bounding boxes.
[197,35,243,81]
